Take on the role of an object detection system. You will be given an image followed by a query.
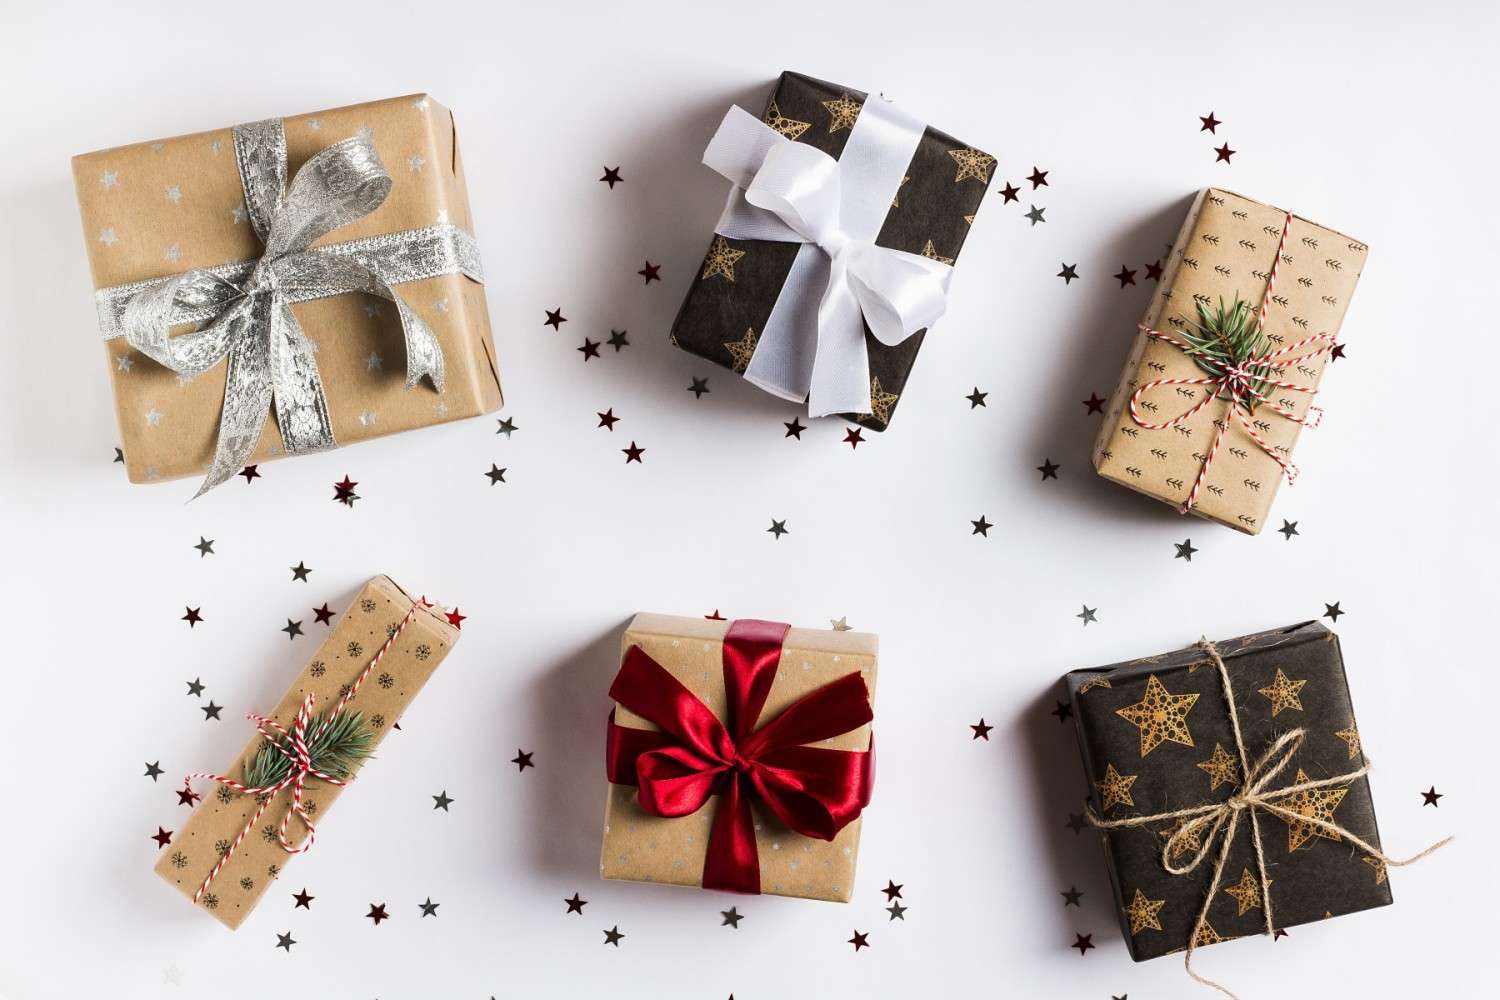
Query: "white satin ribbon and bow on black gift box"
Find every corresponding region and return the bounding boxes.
[704,97,953,417]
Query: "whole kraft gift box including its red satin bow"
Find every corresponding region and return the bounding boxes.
[599,615,878,903]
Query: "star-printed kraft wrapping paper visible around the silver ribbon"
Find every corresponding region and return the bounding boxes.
[74,94,503,483]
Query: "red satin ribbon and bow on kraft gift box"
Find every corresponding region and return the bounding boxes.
[605,619,875,894]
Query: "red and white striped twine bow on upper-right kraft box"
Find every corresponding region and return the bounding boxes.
[1130,211,1337,514]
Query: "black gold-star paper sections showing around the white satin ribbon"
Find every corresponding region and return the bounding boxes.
[672,72,995,430]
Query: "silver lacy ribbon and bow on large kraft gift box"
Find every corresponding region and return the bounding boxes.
[95,118,483,496]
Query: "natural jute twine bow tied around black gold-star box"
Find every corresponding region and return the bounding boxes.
[1085,639,1454,1000]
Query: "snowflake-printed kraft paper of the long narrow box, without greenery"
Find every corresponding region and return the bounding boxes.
[156,576,459,930]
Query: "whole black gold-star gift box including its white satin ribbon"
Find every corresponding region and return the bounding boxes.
[672,72,995,430]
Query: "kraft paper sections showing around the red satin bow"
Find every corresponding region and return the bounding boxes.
[599,615,879,903]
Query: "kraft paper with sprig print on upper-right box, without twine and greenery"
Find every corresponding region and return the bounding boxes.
[1094,187,1368,535]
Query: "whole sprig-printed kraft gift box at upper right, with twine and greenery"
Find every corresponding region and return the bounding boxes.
[1094,187,1368,535]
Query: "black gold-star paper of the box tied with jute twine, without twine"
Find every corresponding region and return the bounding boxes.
[1064,622,1391,961]
